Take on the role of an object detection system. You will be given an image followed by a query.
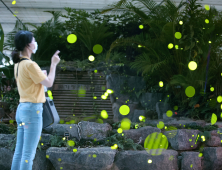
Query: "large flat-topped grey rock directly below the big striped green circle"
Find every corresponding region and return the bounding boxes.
[112,150,178,170]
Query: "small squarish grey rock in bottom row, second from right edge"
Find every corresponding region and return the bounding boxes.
[181,152,202,170]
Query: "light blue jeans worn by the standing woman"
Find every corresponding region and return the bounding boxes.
[11,102,43,170]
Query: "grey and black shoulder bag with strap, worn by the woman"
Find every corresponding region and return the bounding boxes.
[17,58,60,129]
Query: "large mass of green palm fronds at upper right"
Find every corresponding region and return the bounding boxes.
[102,0,222,119]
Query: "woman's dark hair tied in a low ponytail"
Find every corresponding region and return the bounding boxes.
[11,30,33,64]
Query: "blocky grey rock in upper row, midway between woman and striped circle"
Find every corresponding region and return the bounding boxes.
[80,121,112,141]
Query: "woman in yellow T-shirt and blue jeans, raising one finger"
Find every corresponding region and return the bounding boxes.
[11,31,60,170]
